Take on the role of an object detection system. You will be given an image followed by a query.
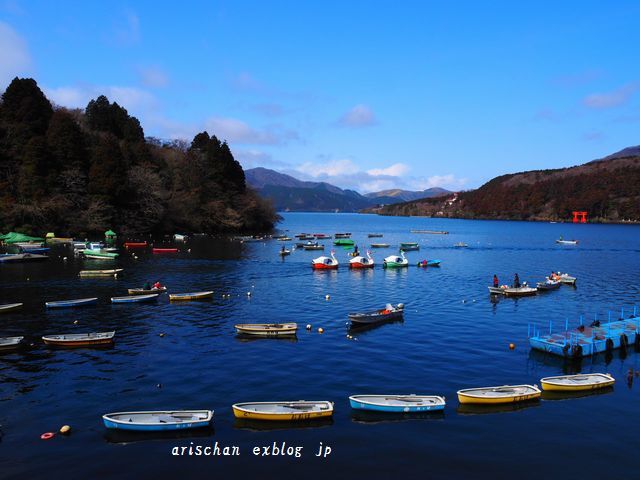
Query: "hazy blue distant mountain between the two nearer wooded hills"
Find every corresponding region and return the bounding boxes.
[245,167,450,212]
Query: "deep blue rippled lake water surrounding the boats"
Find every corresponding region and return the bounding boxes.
[0,213,640,479]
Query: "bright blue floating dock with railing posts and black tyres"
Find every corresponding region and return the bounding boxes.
[529,309,640,358]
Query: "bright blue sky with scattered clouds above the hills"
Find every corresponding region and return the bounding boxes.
[0,0,640,193]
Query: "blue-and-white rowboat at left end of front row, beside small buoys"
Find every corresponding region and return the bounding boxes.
[102,410,213,432]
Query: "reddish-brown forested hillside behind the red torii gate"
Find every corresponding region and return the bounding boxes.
[377,153,640,222]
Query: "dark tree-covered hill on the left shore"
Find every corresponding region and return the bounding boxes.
[0,78,278,236]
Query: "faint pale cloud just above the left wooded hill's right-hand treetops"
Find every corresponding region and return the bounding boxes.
[205,117,299,145]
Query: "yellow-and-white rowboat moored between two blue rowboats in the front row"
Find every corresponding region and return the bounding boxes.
[232,400,333,421]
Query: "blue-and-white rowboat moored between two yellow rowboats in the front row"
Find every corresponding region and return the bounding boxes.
[349,394,446,413]
